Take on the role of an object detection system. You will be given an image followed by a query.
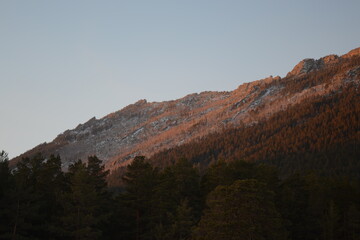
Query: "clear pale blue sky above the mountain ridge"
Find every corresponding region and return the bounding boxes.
[0,0,360,157]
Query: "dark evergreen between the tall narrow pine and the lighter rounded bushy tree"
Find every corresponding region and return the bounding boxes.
[155,159,201,239]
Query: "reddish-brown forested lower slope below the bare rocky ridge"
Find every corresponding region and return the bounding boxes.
[149,84,360,174]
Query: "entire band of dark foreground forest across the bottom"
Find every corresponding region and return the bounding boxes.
[0,152,360,240]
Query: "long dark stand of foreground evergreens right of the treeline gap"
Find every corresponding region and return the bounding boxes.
[117,158,360,240]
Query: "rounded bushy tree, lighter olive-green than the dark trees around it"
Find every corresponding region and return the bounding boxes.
[194,179,286,240]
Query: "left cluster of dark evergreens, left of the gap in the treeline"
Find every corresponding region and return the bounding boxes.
[0,155,110,239]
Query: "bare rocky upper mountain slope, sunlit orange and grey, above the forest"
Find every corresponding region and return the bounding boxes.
[13,48,360,169]
